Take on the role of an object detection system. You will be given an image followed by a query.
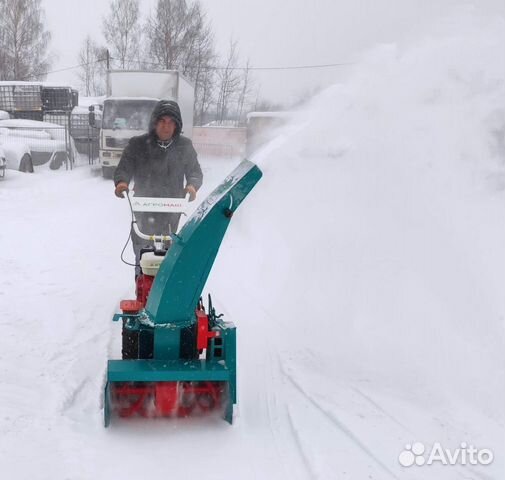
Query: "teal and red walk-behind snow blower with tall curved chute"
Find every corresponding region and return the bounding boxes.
[104,160,262,427]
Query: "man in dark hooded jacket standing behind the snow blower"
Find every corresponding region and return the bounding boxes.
[114,100,203,276]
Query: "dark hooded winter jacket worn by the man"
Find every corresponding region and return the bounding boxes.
[114,100,203,198]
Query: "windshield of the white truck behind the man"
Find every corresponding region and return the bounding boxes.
[102,99,157,131]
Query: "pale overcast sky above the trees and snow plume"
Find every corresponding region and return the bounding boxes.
[42,0,505,102]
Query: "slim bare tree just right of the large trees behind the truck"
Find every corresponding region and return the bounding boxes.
[216,39,241,122]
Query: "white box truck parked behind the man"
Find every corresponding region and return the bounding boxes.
[90,70,194,178]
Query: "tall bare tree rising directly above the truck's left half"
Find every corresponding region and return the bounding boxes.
[102,0,141,70]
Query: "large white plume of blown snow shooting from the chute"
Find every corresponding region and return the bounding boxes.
[210,10,505,422]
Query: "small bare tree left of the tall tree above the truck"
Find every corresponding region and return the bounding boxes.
[77,35,107,97]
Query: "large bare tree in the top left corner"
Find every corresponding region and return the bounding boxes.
[0,0,51,80]
